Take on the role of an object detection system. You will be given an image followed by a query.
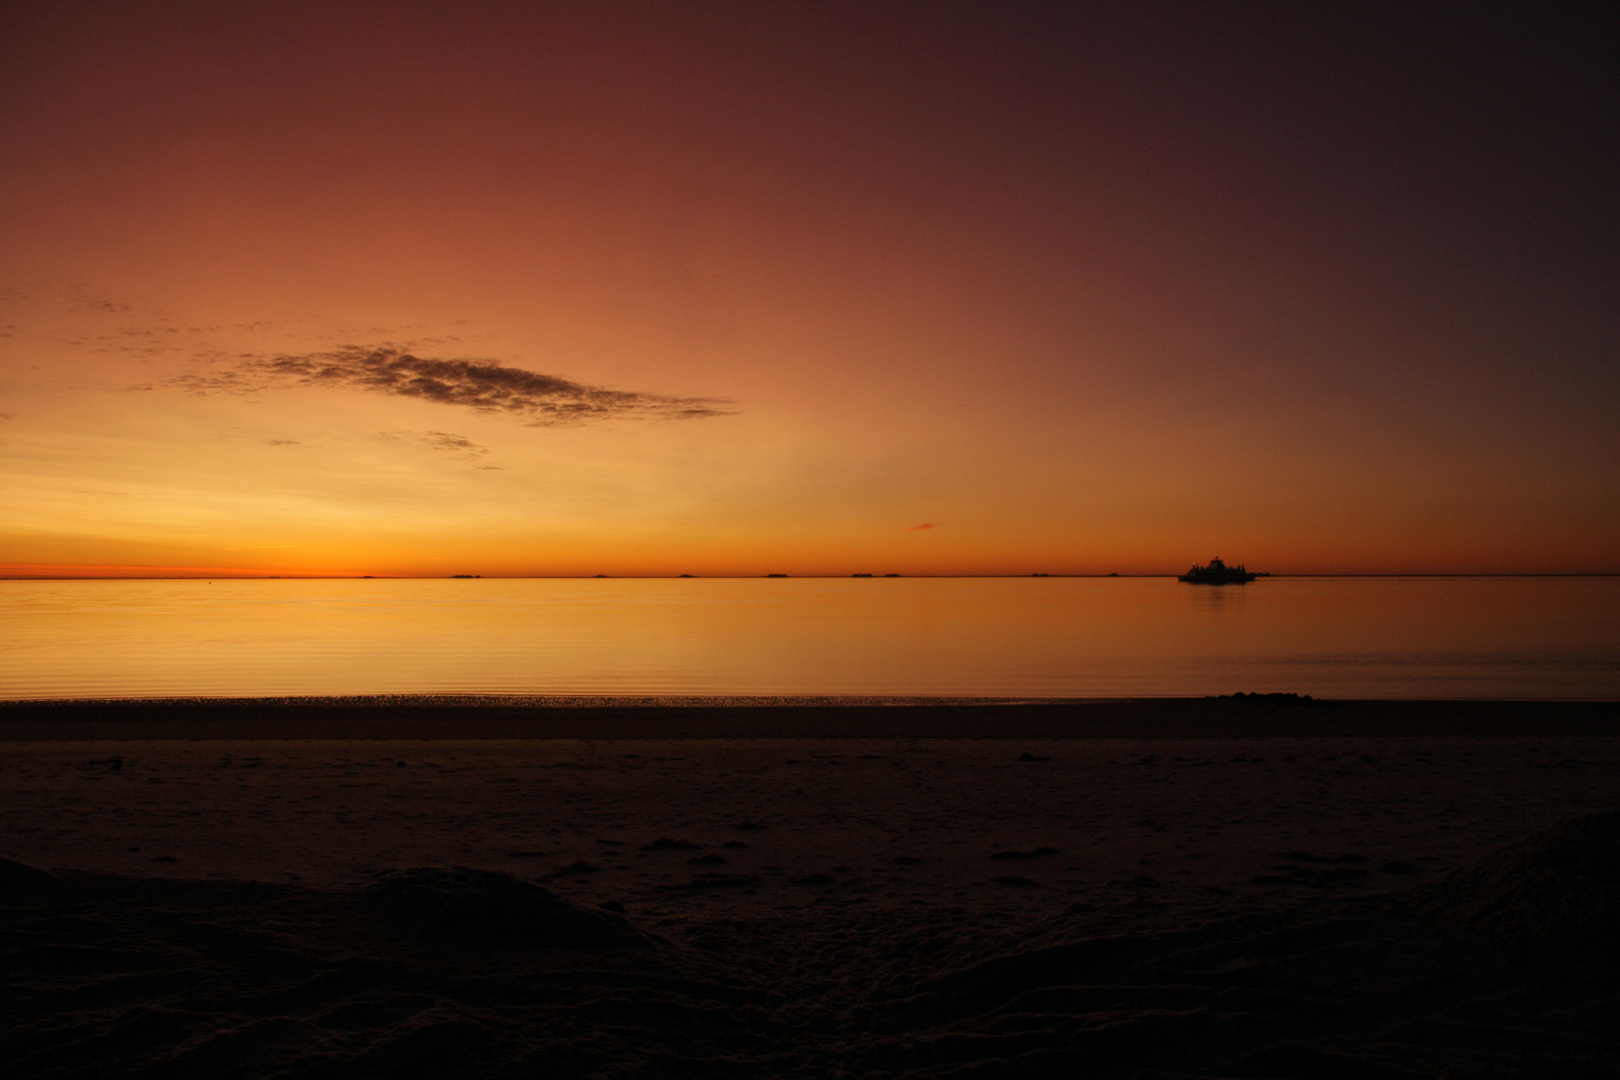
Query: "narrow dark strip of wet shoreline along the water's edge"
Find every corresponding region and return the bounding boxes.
[0,695,1620,742]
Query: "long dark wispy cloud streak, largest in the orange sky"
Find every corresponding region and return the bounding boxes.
[161,345,731,426]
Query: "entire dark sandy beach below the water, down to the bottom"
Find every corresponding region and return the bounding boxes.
[0,703,1620,1077]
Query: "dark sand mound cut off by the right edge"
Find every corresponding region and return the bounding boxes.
[1421,811,1620,967]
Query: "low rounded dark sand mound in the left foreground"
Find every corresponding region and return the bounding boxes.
[360,866,653,949]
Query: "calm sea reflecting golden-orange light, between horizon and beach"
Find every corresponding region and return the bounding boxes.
[0,578,1620,699]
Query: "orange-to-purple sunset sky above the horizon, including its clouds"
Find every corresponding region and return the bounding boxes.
[0,0,1620,576]
